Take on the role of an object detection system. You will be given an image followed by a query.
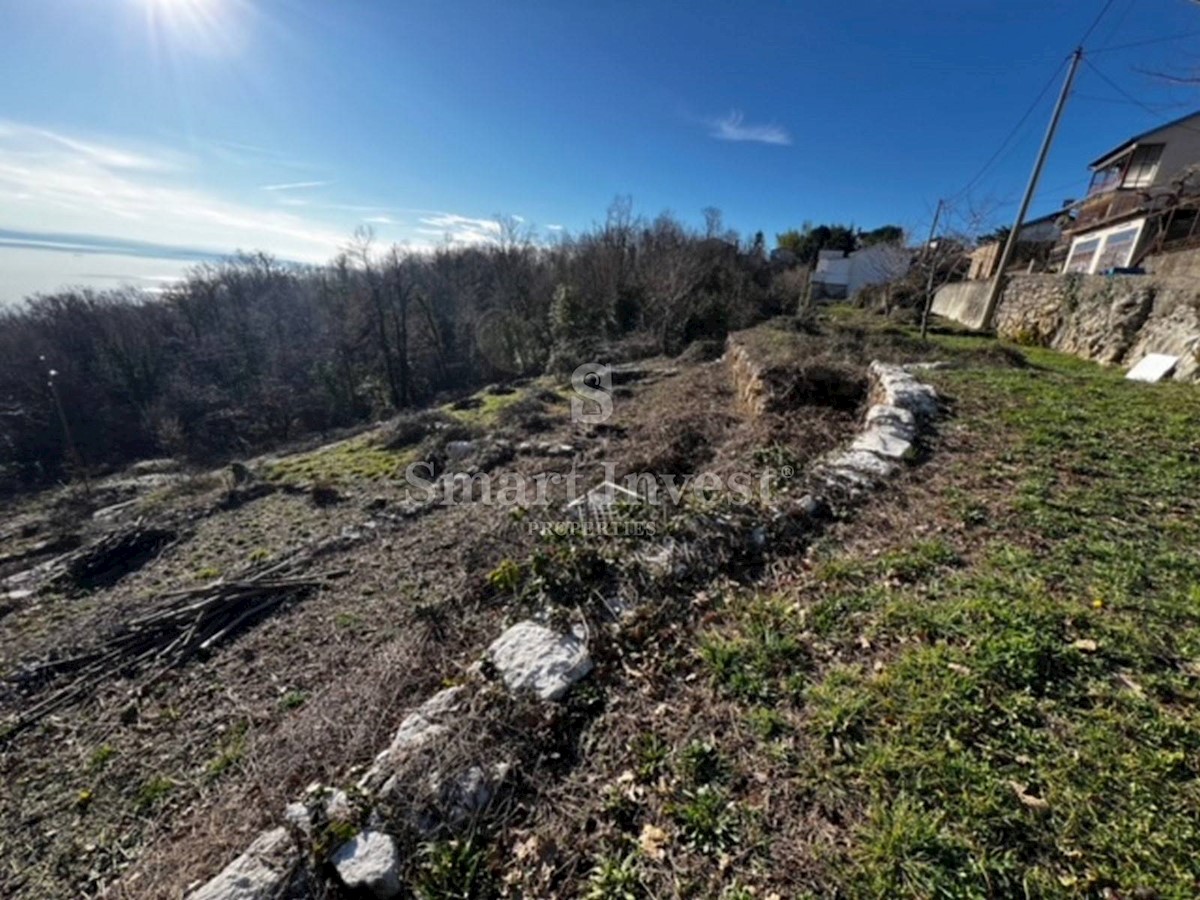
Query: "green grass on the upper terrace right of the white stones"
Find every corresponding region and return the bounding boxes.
[676,335,1200,898]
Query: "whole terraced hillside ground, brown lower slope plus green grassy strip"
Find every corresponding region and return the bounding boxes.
[0,308,1200,898]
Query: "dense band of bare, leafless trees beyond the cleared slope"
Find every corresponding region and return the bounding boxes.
[0,200,825,488]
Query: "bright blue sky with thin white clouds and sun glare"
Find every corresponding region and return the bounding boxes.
[0,0,1200,301]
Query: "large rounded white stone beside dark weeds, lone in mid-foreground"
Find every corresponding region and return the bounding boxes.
[487,620,592,700]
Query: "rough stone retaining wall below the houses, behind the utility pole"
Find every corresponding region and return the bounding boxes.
[934,275,1200,382]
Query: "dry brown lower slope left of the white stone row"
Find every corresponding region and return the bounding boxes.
[0,340,856,898]
